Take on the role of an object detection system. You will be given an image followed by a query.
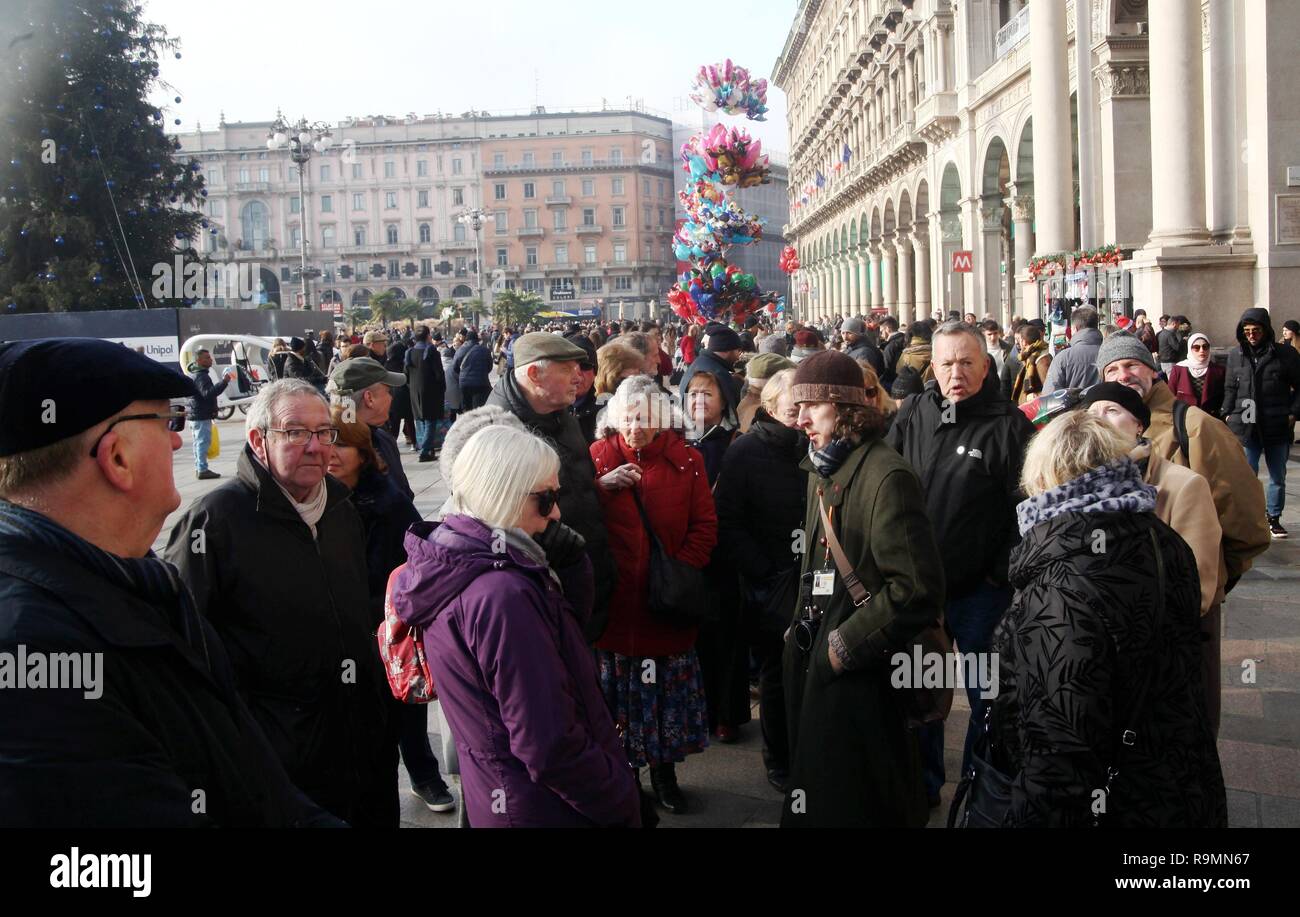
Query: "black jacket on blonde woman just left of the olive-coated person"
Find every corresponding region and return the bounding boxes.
[714,408,807,583]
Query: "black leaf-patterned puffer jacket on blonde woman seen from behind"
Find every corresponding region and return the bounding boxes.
[993,512,1227,827]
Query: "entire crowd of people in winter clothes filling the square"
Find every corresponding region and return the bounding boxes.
[0,296,1284,827]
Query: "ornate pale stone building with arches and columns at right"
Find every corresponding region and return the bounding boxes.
[774,0,1300,343]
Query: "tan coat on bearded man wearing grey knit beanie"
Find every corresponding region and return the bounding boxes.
[1145,381,1271,594]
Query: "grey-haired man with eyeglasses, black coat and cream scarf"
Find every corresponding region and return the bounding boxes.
[166,380,398,827]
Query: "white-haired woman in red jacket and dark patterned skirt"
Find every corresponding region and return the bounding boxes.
[592,376,718,814]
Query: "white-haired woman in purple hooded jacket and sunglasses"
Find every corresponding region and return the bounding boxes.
[389,424,641,827]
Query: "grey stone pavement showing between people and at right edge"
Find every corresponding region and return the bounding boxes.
[155,412,1300,827]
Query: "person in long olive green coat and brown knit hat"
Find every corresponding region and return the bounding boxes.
[781,351,944,827]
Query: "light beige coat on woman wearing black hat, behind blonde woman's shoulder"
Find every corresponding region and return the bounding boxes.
[1132,444,1226,614]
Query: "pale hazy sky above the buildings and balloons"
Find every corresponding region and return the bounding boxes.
[144,0,797,155]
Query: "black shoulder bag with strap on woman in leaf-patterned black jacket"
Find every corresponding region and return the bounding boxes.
[948,528,1165,827]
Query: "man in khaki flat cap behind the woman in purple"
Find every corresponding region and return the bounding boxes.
[488,332,618,643]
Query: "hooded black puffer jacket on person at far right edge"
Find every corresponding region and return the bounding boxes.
[1223,308,1300,446]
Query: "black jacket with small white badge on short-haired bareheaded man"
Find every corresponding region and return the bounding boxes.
[885,369,1034,598]
